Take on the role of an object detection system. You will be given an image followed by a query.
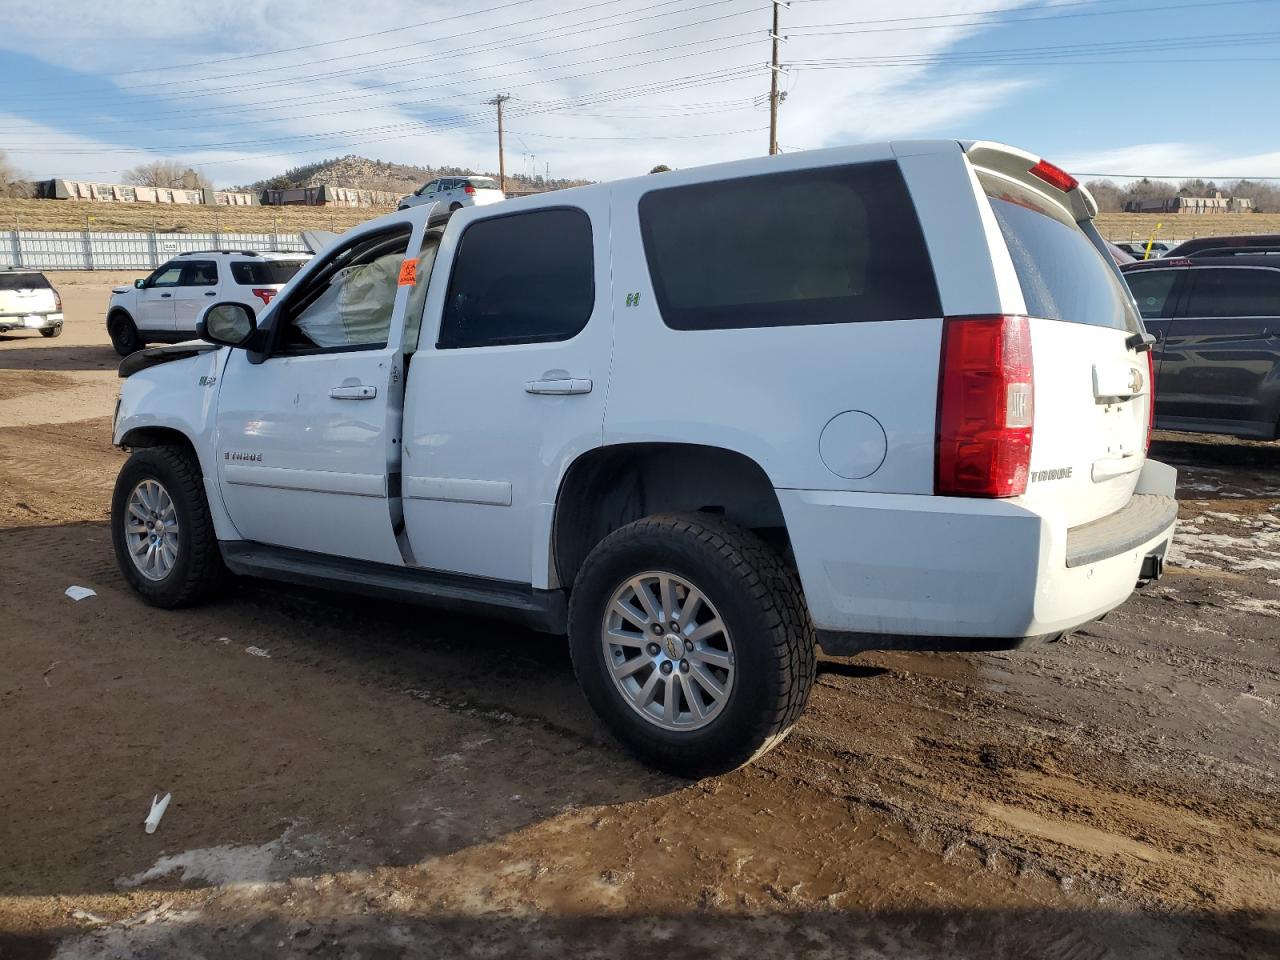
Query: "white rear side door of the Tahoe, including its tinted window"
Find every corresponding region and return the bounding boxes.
[403,193,613,588]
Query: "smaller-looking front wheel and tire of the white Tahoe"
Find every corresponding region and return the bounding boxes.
[111,447,227,608]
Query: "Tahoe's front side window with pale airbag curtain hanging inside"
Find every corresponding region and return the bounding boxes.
[273,224,411,355]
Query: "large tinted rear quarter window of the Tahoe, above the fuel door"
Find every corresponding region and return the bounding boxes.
[640,161,942,330]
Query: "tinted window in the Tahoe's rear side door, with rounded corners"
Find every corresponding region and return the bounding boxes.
[436,207,595,349]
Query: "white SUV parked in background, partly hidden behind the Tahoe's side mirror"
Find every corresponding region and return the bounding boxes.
[106,250,308,357]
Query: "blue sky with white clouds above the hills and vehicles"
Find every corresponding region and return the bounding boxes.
[0,0,1280,186]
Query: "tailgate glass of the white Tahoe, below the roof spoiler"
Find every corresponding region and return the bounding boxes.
[980,177,1139,330]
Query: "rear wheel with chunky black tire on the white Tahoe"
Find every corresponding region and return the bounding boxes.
[570,513,817,777]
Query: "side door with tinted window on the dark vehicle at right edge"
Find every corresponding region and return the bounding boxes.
[1160,266,1280,431]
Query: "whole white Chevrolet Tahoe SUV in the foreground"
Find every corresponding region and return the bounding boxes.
[111,141,1176,774]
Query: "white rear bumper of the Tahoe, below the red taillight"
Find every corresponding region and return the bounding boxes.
[778,461,1176,653]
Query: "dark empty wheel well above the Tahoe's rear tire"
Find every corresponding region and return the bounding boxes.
[553,443,790,586]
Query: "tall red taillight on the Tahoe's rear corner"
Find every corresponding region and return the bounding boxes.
[934,316,1036,497]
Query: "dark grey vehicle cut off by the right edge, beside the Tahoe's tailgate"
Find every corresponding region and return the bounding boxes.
[1124,246,1280,440]
